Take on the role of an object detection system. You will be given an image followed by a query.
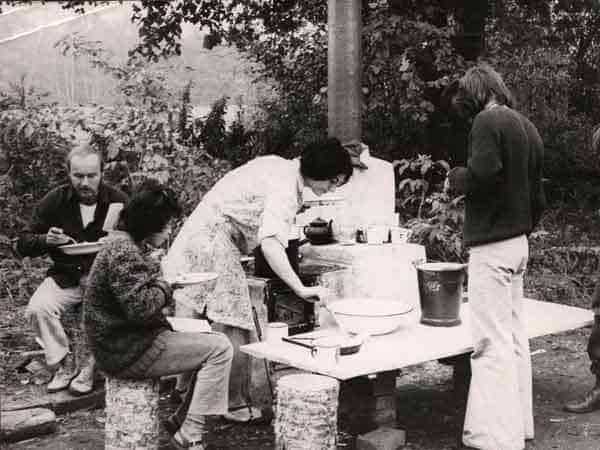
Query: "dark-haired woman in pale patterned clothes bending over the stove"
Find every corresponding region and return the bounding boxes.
[163,138,352,422]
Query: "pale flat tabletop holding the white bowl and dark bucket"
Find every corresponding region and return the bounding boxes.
[241,299,594,380]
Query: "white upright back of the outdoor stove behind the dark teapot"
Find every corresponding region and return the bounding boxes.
[298,150,398,228]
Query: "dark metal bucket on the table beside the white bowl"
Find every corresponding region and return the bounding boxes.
[415,263,467,327]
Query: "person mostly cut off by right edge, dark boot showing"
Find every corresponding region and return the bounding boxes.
[565,126,600,413]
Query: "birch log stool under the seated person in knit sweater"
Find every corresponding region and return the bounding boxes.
[104,376,160,450]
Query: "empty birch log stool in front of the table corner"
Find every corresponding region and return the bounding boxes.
[274,373,339,450]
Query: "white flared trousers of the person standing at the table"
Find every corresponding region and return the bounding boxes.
[463,236,534,450]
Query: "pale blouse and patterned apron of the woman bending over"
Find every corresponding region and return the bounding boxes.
[162,156,303,330]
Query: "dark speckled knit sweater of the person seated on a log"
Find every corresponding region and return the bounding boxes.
[84,233,173,375]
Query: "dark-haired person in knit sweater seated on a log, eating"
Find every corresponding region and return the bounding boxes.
[84,180,233,450]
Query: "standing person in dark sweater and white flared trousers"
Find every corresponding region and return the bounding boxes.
[448,64,545,450]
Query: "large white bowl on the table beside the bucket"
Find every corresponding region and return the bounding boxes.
[328,298,413,335]
